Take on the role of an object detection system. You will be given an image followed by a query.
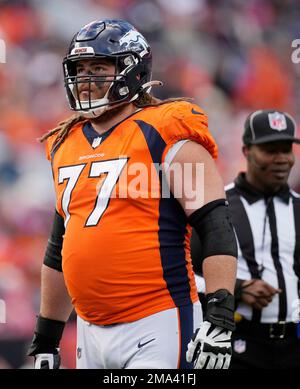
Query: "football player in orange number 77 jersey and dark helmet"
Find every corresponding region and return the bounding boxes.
[29,20,237,369]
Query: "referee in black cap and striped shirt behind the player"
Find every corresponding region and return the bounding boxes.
[191,110,300,369]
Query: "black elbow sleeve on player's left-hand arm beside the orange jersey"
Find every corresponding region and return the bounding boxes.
[44,211,65,271]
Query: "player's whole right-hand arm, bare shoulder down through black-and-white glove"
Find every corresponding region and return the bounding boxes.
[166,141,237,368]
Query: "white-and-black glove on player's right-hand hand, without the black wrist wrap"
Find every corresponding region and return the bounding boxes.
[186,321,232,369]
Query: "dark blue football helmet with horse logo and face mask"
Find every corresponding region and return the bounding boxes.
[63,19,157,118]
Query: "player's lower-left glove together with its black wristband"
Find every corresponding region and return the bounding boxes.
[27,316,65,369]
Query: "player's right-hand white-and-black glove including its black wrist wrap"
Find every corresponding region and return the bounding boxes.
[186,289,235,369]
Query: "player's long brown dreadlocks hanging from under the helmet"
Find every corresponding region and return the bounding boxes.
[38,92,192,150]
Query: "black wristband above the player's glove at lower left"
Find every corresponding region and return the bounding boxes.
[27,316,66,355]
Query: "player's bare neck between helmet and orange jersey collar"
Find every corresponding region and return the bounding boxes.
[91,104,137,135]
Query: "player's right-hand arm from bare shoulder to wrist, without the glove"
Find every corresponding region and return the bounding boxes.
[169,141,237,294]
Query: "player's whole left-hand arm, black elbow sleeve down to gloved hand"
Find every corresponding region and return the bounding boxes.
[28,211,73,369]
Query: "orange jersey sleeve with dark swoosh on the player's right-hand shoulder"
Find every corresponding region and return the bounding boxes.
[162,101,218,161]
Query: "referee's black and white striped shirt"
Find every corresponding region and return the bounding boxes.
[225,173,300,323]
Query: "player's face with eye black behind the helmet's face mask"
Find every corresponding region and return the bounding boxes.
[76,59,115,101]
